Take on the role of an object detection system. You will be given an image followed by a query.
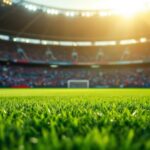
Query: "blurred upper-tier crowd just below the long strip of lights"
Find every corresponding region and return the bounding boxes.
[0,42,150,63]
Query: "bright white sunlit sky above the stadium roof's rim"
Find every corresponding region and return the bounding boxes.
[26,0,150,13]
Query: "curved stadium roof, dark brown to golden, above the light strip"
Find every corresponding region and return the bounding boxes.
[0,0,150,41]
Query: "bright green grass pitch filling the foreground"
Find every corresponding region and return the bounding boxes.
[0,89,150,150]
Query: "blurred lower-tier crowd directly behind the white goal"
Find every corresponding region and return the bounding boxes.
[0,65,150,88]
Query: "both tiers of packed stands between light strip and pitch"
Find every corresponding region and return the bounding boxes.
[0,41,150,88]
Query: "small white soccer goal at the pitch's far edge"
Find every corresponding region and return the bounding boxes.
[68,80,90,88]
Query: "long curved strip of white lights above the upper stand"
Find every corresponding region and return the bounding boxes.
[0,34,150,47]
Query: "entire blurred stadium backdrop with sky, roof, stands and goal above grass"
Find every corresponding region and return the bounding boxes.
[0,0,150,88]
